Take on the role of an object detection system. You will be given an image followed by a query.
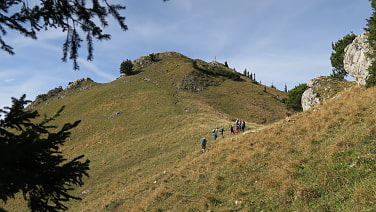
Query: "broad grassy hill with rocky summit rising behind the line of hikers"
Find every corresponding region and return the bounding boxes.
[0,52,288,211]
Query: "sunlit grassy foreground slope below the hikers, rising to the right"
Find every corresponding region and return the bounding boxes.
[138,85,376,211]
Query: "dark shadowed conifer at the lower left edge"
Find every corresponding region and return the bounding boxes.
[0,95,90,212]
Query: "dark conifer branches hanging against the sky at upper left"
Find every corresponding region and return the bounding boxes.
[0,0,128,69]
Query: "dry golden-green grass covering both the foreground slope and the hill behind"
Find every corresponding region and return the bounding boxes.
[2,53,376,212]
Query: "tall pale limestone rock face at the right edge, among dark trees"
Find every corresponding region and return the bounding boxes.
[343,33,372,85]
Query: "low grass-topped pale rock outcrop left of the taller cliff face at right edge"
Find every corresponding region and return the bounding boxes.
[301,76,354,111]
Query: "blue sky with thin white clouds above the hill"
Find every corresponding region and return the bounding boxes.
[0,0,372,108]
